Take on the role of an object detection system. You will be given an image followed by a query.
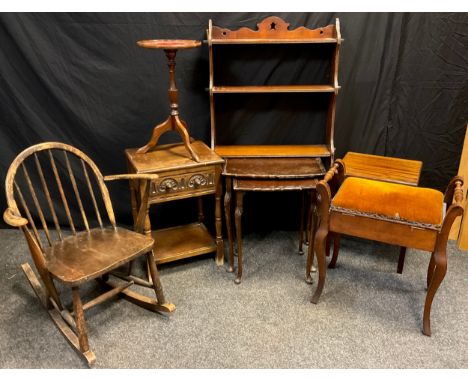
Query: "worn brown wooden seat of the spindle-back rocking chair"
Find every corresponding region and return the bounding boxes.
[45,227,154,286]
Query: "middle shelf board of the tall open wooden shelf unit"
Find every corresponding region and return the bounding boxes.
[212,85,337,93]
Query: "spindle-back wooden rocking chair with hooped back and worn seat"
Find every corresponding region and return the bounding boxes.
[3,142,175,365]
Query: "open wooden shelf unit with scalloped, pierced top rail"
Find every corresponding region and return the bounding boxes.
[207,16,343,163]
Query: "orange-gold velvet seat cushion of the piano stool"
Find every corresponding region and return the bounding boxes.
[330,177,444,228]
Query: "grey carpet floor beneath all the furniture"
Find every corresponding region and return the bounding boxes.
[0,230,468,368]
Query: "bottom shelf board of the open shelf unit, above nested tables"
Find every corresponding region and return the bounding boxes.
[214,145,331,158]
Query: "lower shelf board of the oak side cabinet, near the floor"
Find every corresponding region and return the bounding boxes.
[151,223,216,264]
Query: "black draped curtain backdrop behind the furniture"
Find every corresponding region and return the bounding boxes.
[0,12,468,230]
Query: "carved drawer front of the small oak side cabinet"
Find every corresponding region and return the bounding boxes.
[150,169,215,199]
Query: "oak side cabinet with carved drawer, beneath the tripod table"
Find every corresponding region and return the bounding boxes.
[125,141,224,265]
